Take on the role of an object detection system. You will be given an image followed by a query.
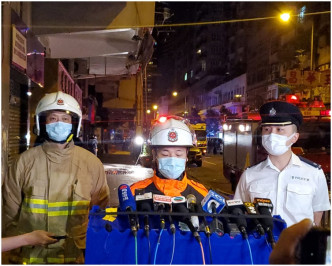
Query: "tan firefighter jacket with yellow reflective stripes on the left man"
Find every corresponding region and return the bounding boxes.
[2,142,109,264]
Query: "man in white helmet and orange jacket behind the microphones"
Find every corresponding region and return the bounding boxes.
[131,116,208,201]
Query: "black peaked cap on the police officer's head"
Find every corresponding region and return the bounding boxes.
[259,101,303,128]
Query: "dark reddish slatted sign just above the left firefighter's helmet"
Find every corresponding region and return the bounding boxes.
[58,61,82,108]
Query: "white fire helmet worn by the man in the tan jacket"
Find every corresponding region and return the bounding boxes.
[36,91,82,137]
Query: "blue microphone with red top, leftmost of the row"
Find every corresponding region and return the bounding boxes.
[118,184,137,236]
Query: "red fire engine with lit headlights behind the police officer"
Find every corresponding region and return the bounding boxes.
[223,95,331,191]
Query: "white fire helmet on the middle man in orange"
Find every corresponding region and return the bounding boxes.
[150,116,196,147]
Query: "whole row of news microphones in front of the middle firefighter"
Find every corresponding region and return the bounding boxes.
[118,184,275,244]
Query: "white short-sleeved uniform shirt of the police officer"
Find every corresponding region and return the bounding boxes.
[234,154,330,226]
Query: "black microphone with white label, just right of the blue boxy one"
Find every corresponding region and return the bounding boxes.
[226,199,248,239]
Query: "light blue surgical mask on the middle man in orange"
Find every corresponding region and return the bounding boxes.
[158,157,186,179]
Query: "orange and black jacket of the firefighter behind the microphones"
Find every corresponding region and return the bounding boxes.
[130,173,208,202]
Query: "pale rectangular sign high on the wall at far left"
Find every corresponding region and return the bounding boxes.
[12,25,27,71]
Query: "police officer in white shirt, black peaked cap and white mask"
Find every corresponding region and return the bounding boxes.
[234,101,330,226]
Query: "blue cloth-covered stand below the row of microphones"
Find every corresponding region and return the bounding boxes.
[85,208,286,264]
